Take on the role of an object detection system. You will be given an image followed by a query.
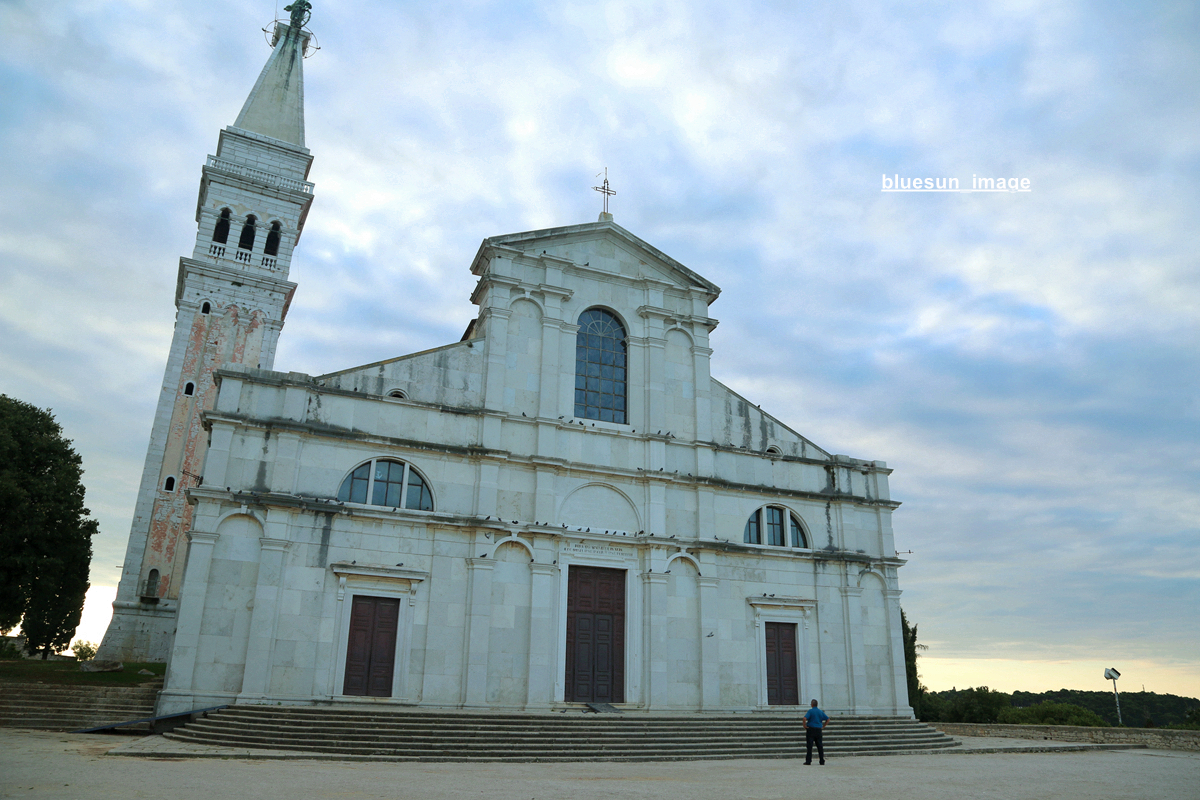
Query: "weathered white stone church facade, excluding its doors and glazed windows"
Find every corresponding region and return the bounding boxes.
[163,221,908,714]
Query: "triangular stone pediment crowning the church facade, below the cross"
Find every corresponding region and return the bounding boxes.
[472,221,721,303]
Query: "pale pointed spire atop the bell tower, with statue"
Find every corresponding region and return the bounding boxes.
[234,0,312,148]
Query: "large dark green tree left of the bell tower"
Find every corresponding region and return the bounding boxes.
[0,395,97,658]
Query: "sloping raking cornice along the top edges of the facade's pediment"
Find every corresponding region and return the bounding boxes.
[470,221,721,303]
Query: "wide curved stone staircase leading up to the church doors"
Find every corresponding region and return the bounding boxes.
[164,705,959,762]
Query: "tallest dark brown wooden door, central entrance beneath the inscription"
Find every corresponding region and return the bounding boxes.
[566,566,625,703]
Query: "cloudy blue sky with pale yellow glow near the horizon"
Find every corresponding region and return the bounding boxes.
[0,0,1200,697]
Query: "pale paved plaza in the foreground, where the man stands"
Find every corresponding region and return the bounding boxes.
[0,729,1200,800]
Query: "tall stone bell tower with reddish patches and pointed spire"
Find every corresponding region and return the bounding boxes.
[97,0,313,661]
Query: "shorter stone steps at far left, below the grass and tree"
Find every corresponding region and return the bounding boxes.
[0,679,162,735]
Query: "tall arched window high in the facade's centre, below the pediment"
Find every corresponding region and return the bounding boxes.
[575,308,629,425]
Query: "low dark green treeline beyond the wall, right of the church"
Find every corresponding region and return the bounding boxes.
[912,686,1200,728]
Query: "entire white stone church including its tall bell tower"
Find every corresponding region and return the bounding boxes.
[100,6,912,716]
